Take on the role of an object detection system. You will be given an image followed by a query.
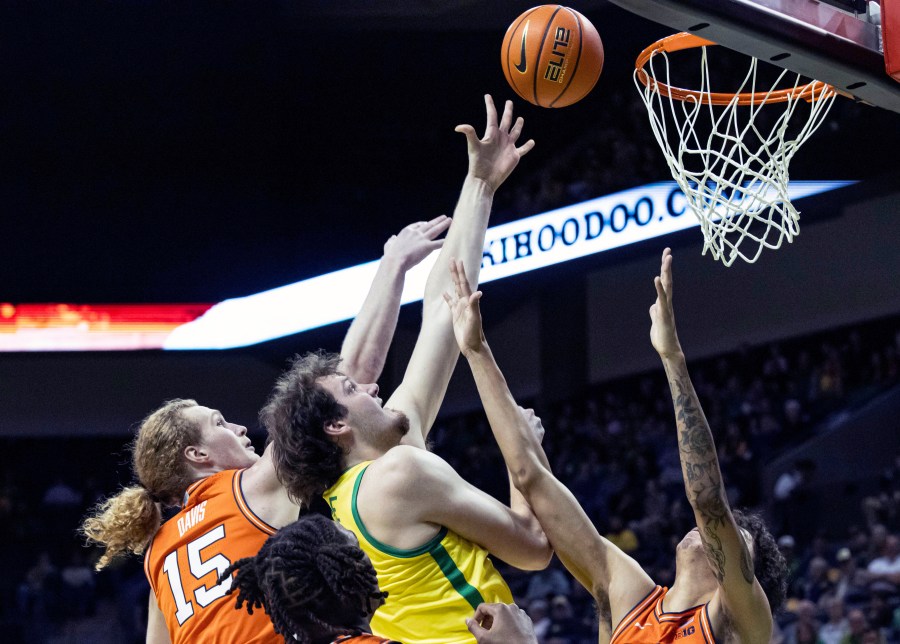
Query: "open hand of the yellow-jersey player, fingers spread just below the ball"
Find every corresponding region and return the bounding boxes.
[456,94,534,190]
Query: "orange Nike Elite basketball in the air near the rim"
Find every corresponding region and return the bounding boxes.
[500,4,603,107]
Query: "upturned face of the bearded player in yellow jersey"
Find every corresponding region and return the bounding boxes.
[320,374,409,448]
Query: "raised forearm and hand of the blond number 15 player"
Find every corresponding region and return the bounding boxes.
[341,215,450,383]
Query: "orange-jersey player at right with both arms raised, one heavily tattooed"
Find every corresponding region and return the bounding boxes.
[445,255,786,644]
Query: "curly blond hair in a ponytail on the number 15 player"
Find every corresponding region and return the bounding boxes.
[81,399,200,570]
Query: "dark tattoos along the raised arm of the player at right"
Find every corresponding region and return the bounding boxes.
[666,363,753,583]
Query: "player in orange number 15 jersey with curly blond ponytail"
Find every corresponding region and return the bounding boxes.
[82,217,450,643]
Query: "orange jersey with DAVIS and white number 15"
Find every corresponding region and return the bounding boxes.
[144,470,284,644]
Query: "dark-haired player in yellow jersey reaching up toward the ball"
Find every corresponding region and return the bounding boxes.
[260,96,551,644]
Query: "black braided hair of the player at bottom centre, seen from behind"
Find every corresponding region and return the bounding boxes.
[219,514,386,644]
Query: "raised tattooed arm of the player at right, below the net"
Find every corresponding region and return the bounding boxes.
[650,248,772,642]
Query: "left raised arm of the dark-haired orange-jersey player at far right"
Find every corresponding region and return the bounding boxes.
[444,263,654,641]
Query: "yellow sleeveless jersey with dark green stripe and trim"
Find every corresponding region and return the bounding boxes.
[323,461,513,644]
